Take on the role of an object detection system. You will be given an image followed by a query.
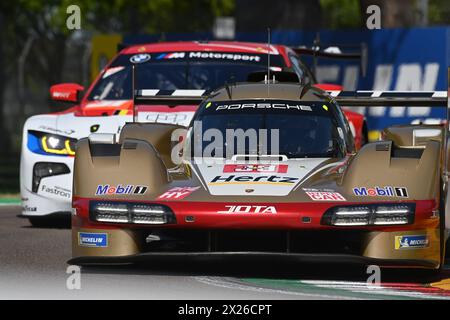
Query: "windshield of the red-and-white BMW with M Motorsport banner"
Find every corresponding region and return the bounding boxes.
[88,52,284,100]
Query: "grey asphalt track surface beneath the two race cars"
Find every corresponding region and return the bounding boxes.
[0,204,450,300]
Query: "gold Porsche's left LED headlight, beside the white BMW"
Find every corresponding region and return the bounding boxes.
[89,201,176,224]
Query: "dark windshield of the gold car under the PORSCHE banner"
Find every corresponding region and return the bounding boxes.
[190,100,345,158]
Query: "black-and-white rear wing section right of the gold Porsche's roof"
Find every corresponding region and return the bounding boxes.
[328,90,447,107]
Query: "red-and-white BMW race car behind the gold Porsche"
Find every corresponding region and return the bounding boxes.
[20,42,366,225]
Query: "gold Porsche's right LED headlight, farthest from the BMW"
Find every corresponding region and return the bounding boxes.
[322,203,416,226]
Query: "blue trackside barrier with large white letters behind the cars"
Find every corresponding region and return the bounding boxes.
[124,27,450,130]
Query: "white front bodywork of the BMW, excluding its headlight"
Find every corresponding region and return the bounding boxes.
[20,108,194,217]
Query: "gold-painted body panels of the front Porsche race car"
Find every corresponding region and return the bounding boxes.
[72,84,443,268]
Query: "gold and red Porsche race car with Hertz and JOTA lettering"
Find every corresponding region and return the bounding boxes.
[69,83,449,270]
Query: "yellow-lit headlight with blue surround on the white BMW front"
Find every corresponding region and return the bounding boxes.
[28,130,77,156]
